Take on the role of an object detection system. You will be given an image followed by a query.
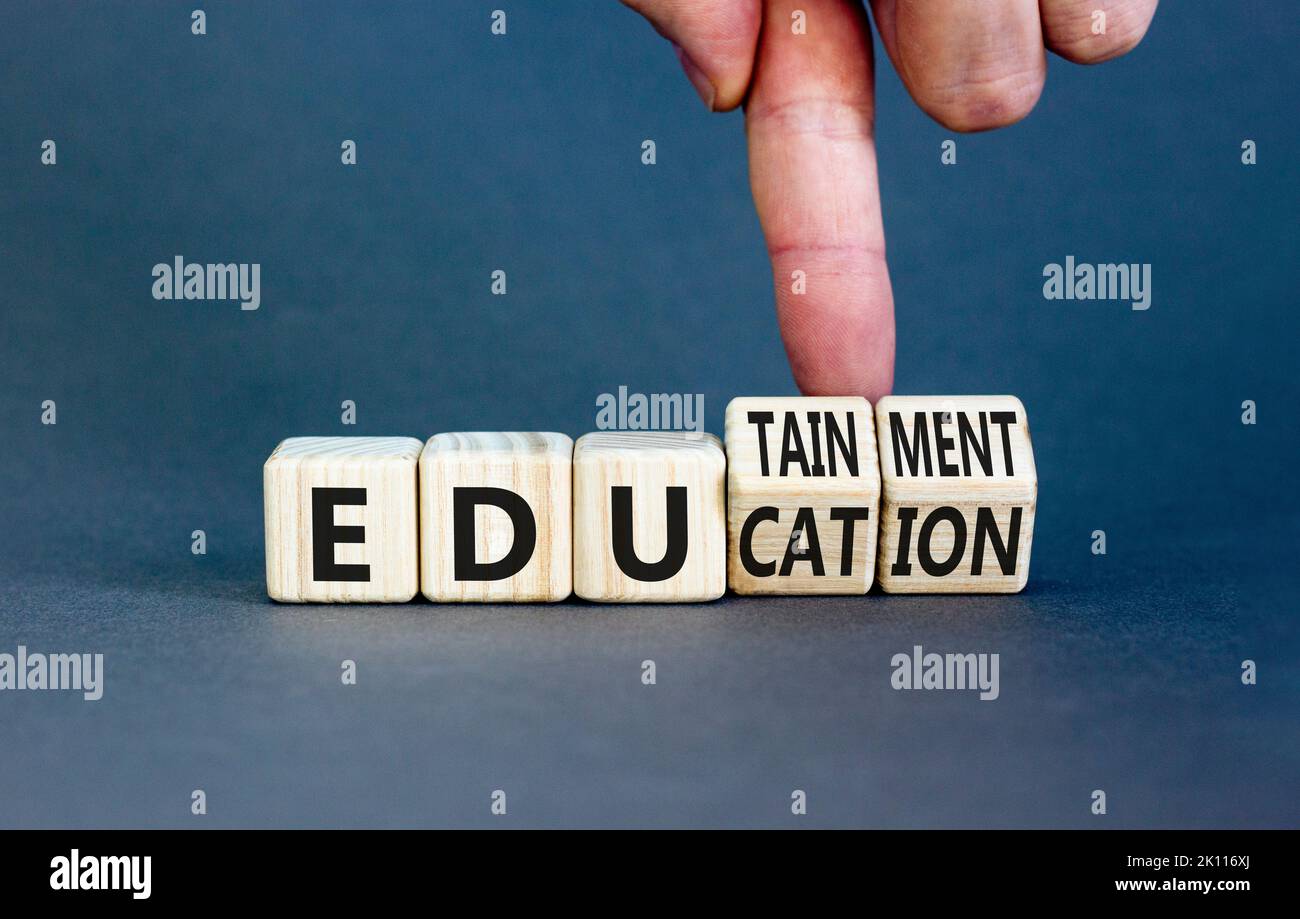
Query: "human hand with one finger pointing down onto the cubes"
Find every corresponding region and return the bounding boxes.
[623,0,1158,400]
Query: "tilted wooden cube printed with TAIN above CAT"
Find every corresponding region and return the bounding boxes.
[727,396,880,594]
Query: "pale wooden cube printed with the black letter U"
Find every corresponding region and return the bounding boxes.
[573,432,727,603]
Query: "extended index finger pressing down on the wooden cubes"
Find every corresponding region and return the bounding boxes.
[745,0,894,400]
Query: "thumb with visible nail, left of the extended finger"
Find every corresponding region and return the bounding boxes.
[623,0,759,112]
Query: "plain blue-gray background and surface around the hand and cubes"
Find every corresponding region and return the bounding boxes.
[0,0,1300,827]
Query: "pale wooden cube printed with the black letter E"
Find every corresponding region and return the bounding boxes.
[263,437,421,603]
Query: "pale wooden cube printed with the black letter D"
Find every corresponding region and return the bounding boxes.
[420,433,573,602]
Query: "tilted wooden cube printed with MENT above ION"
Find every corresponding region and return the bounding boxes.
[876,395,1039,594]
